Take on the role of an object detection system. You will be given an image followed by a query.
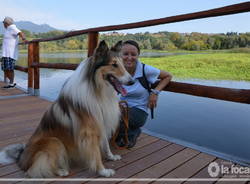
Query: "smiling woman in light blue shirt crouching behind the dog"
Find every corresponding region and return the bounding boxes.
[116,40,172,148]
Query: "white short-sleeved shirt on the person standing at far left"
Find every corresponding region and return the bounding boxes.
[2,24,21,60]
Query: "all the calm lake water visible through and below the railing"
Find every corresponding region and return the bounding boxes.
[0,53,250,165]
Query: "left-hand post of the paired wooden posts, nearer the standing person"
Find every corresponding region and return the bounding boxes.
[28,43,34,95]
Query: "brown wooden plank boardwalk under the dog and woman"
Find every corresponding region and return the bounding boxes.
[0,82,247,184]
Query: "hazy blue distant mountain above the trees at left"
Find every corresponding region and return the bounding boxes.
[0,21,58,34]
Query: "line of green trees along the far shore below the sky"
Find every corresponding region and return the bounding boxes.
[0,30,250,51]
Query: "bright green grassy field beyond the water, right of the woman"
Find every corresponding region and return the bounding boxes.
[140,52,250,81]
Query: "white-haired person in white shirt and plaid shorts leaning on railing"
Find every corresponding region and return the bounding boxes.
[1,17,27,88]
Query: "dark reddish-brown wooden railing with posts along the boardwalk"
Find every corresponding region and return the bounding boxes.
[15,2,250,104]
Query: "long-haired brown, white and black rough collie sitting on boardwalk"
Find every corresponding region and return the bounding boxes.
[0,41,132,178]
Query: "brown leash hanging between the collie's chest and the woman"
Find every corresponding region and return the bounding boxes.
[111,100,129,150]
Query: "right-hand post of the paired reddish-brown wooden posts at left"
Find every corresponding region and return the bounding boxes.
[33,42,40,96]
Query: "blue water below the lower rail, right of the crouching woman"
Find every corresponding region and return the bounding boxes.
[145,92,250,164]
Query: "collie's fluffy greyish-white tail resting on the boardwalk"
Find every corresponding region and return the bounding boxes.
[0,144,25,164]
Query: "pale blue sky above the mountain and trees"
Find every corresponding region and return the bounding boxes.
[0,0,250,33]
